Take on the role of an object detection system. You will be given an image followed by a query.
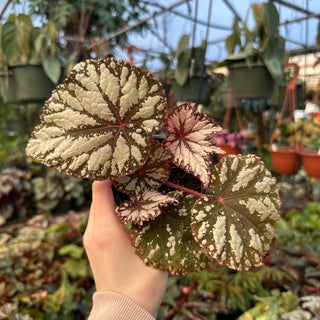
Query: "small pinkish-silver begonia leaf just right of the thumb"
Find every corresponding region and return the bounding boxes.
[116,190,178,225]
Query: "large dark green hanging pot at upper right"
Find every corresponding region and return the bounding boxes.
[229,60,275,99]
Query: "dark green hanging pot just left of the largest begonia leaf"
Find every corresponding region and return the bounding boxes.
[11,64,56,103]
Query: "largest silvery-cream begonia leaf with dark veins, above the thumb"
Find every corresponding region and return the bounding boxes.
[27,58,166,180]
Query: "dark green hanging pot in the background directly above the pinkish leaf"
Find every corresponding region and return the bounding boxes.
[171,76,209,104]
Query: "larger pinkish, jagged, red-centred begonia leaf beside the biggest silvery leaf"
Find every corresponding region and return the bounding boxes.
[164,103,224,187]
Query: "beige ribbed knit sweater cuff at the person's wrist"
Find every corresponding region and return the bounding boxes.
[88,291,155,320]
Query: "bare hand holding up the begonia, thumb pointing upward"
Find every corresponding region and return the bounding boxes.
[83,180,168,316]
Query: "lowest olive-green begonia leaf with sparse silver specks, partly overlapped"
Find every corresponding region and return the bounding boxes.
[130,192,213,274]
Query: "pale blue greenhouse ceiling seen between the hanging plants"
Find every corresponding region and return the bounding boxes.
[0,0,320,71]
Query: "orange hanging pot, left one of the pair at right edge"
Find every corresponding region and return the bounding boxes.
[269,147,299,174]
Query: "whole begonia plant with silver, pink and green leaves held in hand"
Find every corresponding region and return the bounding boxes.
[27,58,280,274]
